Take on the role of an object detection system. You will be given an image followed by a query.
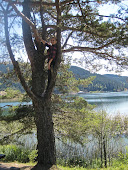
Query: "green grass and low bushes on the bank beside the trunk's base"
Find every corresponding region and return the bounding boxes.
[0,145,128,170]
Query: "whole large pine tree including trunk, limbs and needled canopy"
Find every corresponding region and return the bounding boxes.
[0,0,128,170]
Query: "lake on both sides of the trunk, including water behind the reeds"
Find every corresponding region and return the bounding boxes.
[0,91,128,155]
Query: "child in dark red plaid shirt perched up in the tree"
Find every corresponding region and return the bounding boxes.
[41,37,57,86]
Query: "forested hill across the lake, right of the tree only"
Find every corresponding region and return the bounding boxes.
[70,66,128,91]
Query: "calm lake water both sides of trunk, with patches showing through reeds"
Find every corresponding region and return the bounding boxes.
[0,91,128,151]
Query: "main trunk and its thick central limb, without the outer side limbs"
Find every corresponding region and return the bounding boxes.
[23,0,56,170]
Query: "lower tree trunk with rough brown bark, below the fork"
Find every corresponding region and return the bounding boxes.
[33,99,56,170]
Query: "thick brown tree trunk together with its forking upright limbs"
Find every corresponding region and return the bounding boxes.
[5,0,61,170]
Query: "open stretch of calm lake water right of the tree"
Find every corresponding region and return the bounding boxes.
[79,91,128,115]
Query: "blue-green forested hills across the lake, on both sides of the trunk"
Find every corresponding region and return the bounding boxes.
[0,63,128,91]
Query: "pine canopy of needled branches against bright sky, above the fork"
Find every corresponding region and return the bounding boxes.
[1,0,128,69]
